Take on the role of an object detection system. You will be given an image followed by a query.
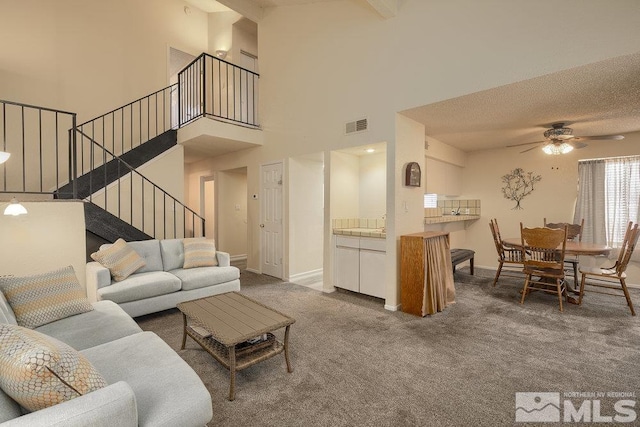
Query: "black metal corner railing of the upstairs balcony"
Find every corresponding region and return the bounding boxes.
[178,53,260,127]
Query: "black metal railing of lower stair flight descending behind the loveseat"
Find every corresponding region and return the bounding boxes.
[77,129,205,239]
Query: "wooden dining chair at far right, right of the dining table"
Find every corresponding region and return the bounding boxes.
[578,222,640,316]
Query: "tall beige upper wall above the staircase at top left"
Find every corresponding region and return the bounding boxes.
[0,0,208,122]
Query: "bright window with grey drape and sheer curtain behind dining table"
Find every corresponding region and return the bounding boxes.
[574,156,640,247]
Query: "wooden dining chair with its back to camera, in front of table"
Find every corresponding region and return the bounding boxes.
[520,223,567,311]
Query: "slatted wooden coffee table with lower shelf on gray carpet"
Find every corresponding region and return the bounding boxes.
[178,292,295,400]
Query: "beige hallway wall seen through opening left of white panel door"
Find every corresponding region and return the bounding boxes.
[215,169,247,257]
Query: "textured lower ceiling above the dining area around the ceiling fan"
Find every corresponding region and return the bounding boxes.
[402,53,640,151]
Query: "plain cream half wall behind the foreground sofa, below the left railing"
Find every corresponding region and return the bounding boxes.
[0,201,87,289]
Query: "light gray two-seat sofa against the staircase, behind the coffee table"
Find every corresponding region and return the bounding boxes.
[86,239,240,317]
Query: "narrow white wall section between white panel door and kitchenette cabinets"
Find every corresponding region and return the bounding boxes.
[286,154,324,278]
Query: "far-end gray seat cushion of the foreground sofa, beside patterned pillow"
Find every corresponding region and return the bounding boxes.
[36,301,142,350]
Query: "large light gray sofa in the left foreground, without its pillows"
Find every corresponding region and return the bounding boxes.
[0,292,213,427]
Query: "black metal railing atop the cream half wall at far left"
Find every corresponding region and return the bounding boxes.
[0,100,77,197]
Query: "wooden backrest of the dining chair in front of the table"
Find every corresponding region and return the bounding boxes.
[520,223,567,275]
